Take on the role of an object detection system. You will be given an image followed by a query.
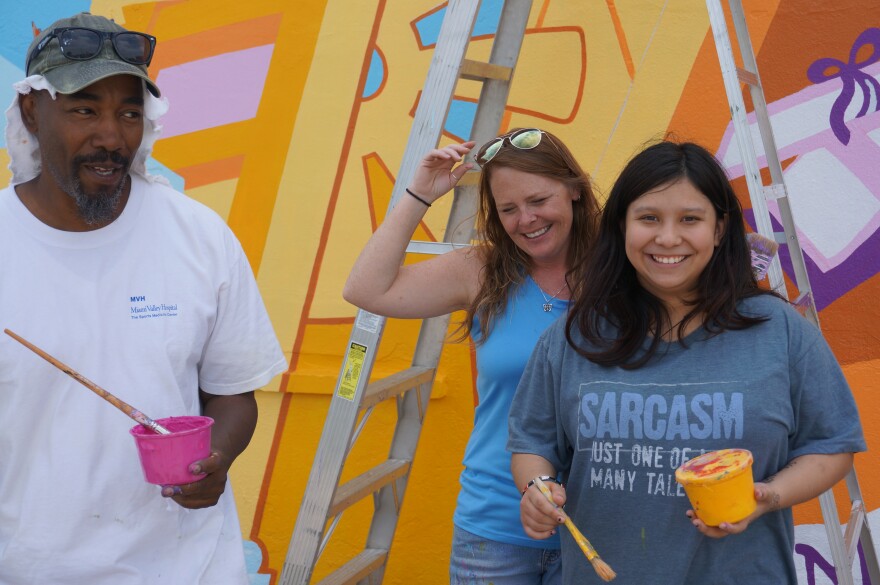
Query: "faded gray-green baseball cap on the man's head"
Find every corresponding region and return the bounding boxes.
[26,12,160,97]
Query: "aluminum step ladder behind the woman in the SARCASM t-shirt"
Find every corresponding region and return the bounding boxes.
[706,0,880,585]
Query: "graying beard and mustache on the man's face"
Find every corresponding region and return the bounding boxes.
[48,151,131,225]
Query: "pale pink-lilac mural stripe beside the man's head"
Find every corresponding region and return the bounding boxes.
[157,45,274,138]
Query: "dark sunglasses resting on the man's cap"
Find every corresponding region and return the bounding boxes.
[28,27,156,73]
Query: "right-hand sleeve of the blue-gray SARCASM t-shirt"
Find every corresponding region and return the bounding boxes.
[787,311,867,458]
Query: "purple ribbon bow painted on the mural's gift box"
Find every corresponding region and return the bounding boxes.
[807,28,880,144]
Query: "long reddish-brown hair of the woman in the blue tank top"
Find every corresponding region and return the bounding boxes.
[462,128,599,343]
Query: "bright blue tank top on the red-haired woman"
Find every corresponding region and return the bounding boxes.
[453,277,568,548]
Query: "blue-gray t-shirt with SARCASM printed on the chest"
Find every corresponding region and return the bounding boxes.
[507,296,866,585]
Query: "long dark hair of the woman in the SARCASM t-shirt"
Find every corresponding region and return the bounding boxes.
[566,140,772,369]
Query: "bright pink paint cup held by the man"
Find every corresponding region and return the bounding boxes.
[128,416,214,485]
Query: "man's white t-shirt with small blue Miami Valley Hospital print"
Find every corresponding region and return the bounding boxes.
[0,176,286,585]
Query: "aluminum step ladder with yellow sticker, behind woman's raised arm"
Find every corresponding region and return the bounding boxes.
[279,0,532,585]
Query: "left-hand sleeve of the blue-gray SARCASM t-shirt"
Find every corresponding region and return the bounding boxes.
[507,326,570,472]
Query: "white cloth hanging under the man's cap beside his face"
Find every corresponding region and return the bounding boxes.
[6,75,168,185]
